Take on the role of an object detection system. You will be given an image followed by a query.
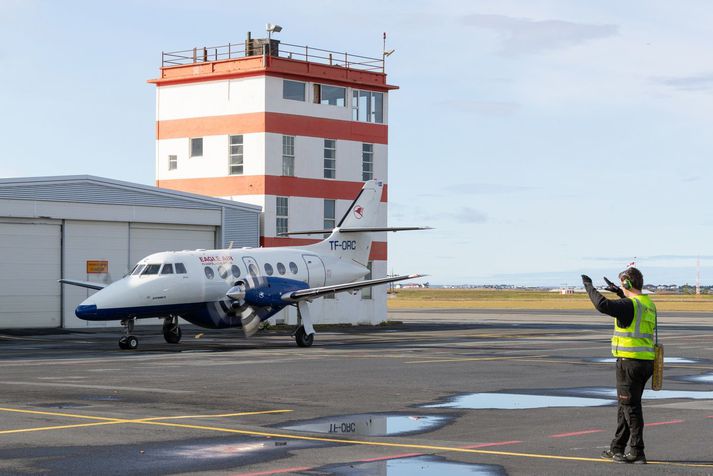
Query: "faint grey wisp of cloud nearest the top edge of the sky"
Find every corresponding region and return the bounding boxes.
[461,14,619,56]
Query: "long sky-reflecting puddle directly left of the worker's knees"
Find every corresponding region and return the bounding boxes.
[424,393,616,410]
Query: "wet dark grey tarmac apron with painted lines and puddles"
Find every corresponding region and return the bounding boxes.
[0,309,713,476]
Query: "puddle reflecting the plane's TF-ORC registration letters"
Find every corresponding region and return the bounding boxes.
[281,414,450,436]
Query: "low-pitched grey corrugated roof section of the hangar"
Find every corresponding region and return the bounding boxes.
[0,175,261,212]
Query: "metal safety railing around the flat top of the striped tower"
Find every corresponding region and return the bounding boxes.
[161,40,385,73]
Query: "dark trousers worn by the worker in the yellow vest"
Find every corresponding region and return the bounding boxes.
[611,358,654,456]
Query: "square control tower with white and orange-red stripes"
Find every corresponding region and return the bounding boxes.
[149,34,398,323]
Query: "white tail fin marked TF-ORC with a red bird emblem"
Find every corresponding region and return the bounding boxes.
[311,180,385,266]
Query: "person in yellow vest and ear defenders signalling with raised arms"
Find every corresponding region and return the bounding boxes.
[582,267,656,464]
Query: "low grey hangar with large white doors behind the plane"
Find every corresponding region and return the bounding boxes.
[0,175,261,329]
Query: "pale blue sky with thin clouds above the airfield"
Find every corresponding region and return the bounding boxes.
[0,0,713,286]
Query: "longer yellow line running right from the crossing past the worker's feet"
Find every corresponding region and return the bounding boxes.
[135,422,713,468]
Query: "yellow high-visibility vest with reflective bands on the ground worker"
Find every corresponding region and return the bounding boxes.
[612,294,656,360]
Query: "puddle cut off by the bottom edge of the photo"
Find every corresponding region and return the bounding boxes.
[310,456,507,476]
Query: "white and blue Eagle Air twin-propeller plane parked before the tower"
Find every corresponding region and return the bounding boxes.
[60,180,421,349]
